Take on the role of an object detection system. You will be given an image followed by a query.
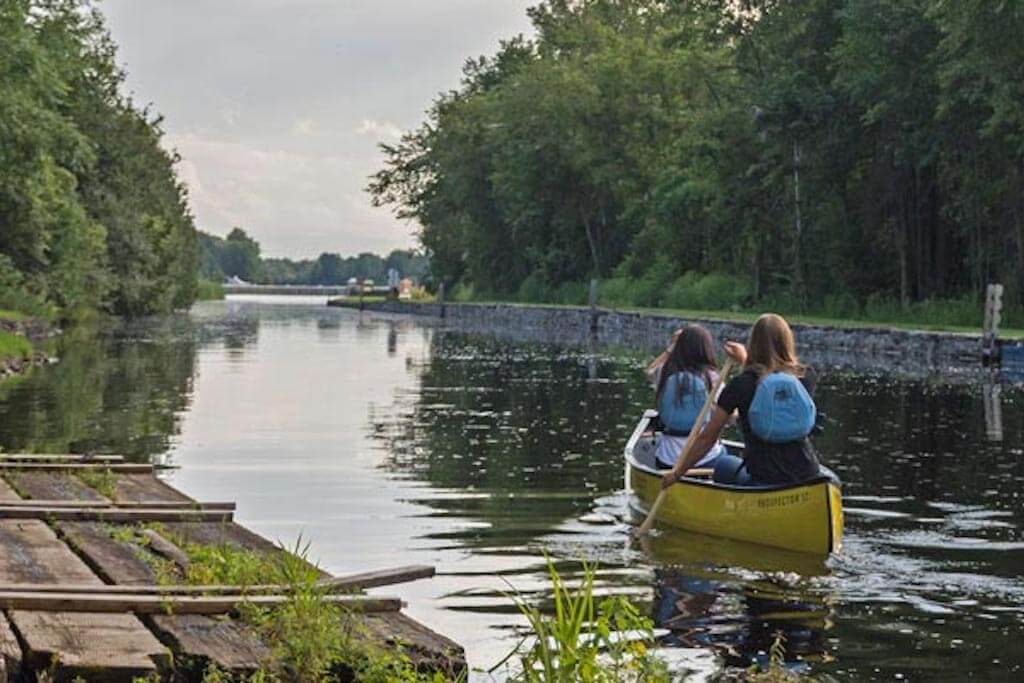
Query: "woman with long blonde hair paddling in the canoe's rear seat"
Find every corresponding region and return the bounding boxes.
[663,313,821,486]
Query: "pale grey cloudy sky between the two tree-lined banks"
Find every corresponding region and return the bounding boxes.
[101,0,536,257]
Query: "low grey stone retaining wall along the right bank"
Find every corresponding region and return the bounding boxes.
[328,299,982,371]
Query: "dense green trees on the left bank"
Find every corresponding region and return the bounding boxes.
[0,0,198,315]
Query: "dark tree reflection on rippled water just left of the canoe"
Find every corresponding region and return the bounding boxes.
[372,333,645,540]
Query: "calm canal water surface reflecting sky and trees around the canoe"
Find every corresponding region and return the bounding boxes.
[0,298,1024,681]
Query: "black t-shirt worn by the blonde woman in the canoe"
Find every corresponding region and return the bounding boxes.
[718,369,820,483]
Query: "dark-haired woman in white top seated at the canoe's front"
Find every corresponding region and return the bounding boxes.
[655,325,724,467]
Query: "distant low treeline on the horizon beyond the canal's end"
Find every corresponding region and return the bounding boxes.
[199,227,429,285]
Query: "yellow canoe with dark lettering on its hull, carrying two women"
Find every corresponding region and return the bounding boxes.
[626,411,843,555]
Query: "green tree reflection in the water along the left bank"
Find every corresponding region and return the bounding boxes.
[0,317,196,461]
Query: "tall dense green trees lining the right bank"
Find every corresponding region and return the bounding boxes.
[370,0,1024,315]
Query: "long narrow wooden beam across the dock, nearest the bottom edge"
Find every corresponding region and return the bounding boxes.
[0,591,401,614]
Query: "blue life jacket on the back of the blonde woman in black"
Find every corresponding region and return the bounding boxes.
[746,373,817,443]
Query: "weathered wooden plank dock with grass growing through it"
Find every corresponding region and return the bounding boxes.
[0,455,465,681]
